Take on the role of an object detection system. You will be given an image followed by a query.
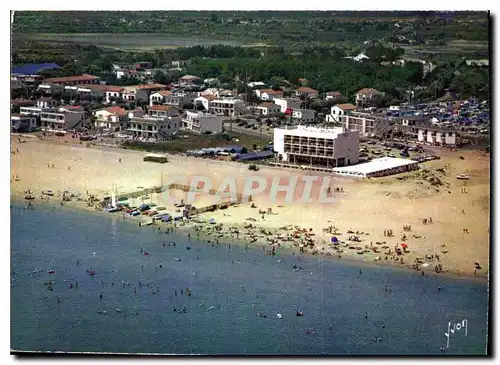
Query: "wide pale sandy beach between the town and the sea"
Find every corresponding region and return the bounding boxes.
[11,136,490,278]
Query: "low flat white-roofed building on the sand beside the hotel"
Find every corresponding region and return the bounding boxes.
[333,157,418,178]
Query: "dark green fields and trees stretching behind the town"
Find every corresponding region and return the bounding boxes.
[12,12,489,104]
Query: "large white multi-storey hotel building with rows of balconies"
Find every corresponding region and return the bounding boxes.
[274,125,359,169]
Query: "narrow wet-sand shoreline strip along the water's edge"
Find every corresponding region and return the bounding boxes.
[11,194,489,283]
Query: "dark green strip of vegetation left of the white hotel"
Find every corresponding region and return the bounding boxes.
[124,132,270,153]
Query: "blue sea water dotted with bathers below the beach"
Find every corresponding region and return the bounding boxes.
[11,204,488,355]
